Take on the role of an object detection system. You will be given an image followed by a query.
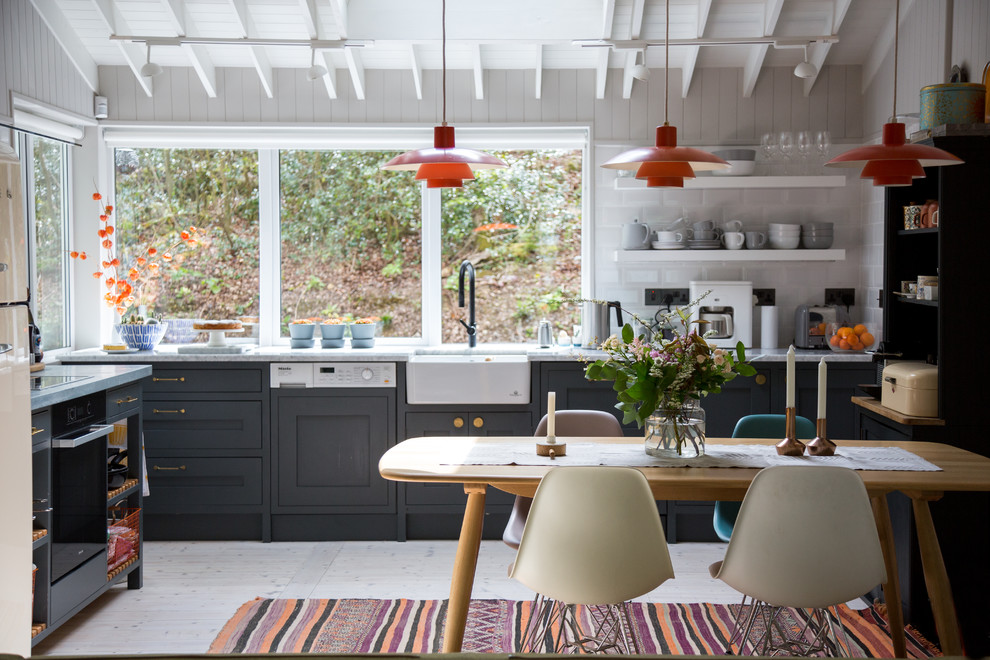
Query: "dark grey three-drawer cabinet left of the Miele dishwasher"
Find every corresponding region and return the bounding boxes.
[141,362,271,541]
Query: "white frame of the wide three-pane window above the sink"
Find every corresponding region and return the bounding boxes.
[101,122,595,347]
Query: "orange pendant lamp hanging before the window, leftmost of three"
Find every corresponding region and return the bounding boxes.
[382,0,506,188]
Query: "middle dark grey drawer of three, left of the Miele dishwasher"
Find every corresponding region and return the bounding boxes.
[144,400,261,451]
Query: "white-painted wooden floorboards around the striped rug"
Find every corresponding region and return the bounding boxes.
[33,541,741,656]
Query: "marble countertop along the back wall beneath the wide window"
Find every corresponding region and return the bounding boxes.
[62,343,873,364]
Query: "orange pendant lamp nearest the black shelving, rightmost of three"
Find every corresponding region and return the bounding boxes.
[825,0,963,186]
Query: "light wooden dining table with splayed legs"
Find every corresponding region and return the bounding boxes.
[378,436,990,658]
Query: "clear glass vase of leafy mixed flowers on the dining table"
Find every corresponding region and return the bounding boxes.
[585,296,756,458]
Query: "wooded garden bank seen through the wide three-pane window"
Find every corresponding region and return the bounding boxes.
[115,142,583,343]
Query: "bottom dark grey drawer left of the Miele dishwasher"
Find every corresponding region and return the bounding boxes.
[144,458,264,513]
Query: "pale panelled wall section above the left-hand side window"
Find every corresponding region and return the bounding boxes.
[0,0,93,118]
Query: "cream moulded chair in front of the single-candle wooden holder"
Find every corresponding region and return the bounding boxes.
[509,467,674,653]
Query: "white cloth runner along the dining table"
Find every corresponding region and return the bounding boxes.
[442,441,942,472]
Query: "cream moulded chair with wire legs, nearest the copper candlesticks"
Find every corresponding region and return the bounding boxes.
[709,466,887,656]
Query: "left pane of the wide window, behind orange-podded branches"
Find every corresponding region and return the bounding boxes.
[114,149,259,341]
